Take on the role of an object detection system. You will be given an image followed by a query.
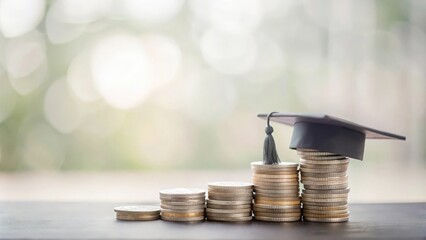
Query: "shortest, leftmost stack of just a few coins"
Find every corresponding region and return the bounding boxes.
[114,206,160,221]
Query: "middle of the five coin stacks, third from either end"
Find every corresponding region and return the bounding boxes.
[206,182,253,222]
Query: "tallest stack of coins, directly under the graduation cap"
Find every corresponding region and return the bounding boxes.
[297,149,349,222]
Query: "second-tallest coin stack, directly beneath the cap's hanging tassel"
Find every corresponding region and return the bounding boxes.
[251,162,301,222]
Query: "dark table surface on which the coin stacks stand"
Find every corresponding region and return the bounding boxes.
[0,202,426,240]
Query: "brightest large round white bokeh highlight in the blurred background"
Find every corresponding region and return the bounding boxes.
[91,33,153,109]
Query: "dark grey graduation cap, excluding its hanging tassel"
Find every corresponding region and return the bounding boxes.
[257,113,405,160]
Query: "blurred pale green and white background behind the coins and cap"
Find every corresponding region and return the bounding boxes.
[0,0,426,202]
